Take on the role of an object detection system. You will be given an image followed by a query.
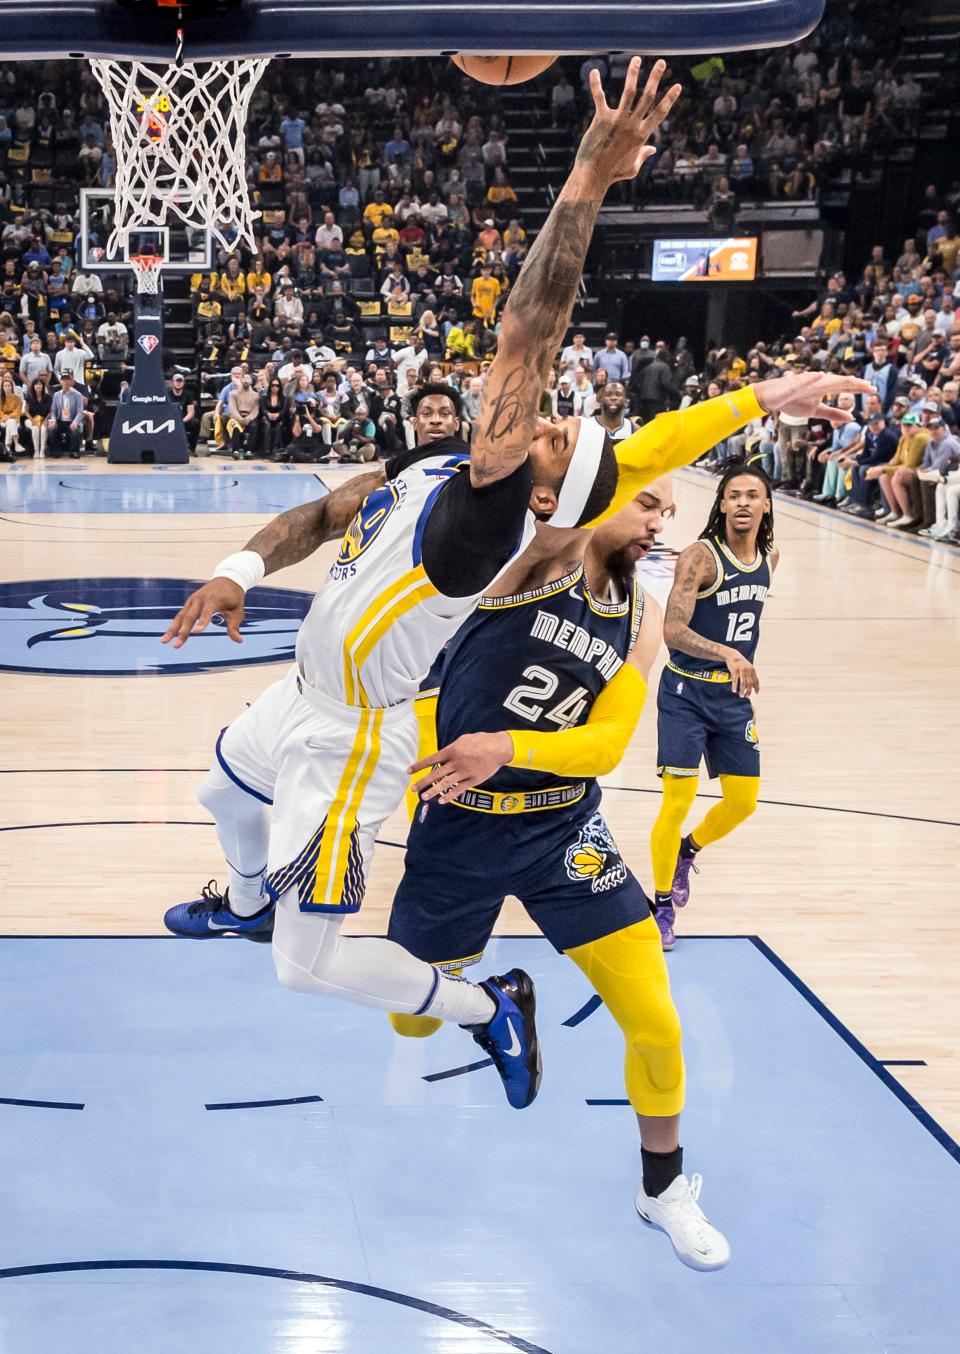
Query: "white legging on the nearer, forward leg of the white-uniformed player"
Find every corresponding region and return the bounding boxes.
[274,888,496,1025]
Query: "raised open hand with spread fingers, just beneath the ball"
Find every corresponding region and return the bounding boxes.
[577,57,682,191]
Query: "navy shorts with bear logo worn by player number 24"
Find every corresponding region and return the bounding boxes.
[387,791,650,968]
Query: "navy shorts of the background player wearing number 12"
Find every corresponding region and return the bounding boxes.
[657,668,760,777]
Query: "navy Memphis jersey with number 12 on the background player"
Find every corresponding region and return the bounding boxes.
[670,538,770,674]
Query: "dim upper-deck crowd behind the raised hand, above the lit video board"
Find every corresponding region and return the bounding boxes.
[551,0,926,208]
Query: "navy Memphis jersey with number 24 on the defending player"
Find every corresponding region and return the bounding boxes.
[421,565,643,791]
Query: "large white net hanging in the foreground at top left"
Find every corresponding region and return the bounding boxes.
[91,57,268,259]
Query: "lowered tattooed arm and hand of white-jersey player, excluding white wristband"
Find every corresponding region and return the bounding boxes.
[161,470,383,649]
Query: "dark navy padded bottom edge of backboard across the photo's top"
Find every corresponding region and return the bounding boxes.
[0,0,826,61]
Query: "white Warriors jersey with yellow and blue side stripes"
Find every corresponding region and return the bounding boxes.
[297,444,535,708]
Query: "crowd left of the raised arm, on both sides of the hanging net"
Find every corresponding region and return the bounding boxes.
[0,61,527,459]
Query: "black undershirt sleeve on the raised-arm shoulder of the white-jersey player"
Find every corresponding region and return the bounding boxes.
[422,460,533,597]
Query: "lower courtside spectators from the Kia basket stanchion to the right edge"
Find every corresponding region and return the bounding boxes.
[181,187,960,544]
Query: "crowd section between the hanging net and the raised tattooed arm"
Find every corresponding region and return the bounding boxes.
[171,62,528,462]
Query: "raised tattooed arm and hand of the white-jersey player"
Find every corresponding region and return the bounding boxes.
[470,57,680,486]
